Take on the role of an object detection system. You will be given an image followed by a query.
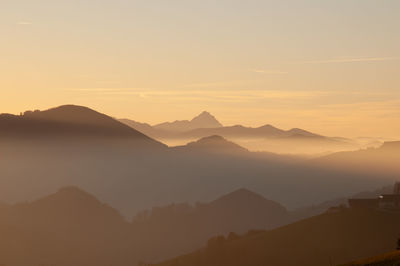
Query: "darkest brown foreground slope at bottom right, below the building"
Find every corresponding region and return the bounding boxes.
[155,209,400,266]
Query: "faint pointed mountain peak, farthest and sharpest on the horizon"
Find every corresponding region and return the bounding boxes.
[154,111,222,132]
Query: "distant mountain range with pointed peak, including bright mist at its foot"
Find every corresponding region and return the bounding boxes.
[119,112,360,154]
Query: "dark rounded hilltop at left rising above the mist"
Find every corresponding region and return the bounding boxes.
[0,105,163,147]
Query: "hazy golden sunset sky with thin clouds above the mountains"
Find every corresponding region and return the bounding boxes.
[0,0,400,139]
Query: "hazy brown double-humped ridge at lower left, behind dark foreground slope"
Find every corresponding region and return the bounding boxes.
[0,187,288,266]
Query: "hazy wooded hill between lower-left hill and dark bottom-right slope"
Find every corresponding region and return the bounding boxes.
[132,189,289,262]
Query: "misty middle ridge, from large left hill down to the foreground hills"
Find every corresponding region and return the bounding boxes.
[0,105,397,217]
